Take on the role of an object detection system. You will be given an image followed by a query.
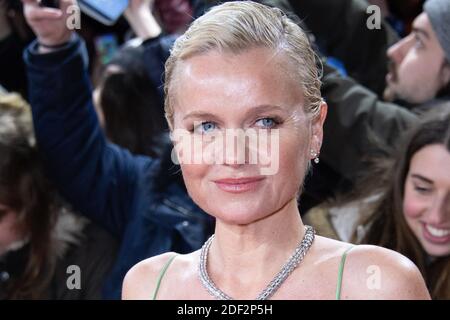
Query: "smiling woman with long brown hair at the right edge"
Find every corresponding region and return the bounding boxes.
[306,104,450,299]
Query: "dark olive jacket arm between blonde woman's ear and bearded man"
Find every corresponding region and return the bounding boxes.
[320,65,417,181]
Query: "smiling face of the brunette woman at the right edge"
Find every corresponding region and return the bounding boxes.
[403,144,450,257]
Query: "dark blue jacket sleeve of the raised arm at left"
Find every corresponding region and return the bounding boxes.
[24,36,157,236]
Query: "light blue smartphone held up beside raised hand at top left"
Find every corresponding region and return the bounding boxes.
[78,0,128,26]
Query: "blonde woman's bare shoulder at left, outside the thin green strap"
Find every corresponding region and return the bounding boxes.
[122,252,181,300]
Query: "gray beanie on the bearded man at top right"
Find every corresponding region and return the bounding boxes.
[423,0,450,62]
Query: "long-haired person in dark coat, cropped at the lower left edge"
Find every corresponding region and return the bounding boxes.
[0,94,116,299]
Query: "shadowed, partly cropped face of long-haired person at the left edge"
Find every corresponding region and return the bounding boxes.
[0,203,22,255]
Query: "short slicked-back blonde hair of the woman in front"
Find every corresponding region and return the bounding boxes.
[164,1,323,129]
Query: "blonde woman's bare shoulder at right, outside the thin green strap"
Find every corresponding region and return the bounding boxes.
[341,245,430,300]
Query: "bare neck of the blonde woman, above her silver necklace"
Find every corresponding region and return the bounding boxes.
[207,198,305,299]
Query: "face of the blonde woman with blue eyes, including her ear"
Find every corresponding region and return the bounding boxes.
[172,48,326,225]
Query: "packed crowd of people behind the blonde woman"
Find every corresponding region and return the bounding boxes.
[0,0,450,299]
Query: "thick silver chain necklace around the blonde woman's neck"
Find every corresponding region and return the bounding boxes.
[199,226,315,300]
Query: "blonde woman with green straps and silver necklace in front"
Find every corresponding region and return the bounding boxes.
[122,1,429,299]
